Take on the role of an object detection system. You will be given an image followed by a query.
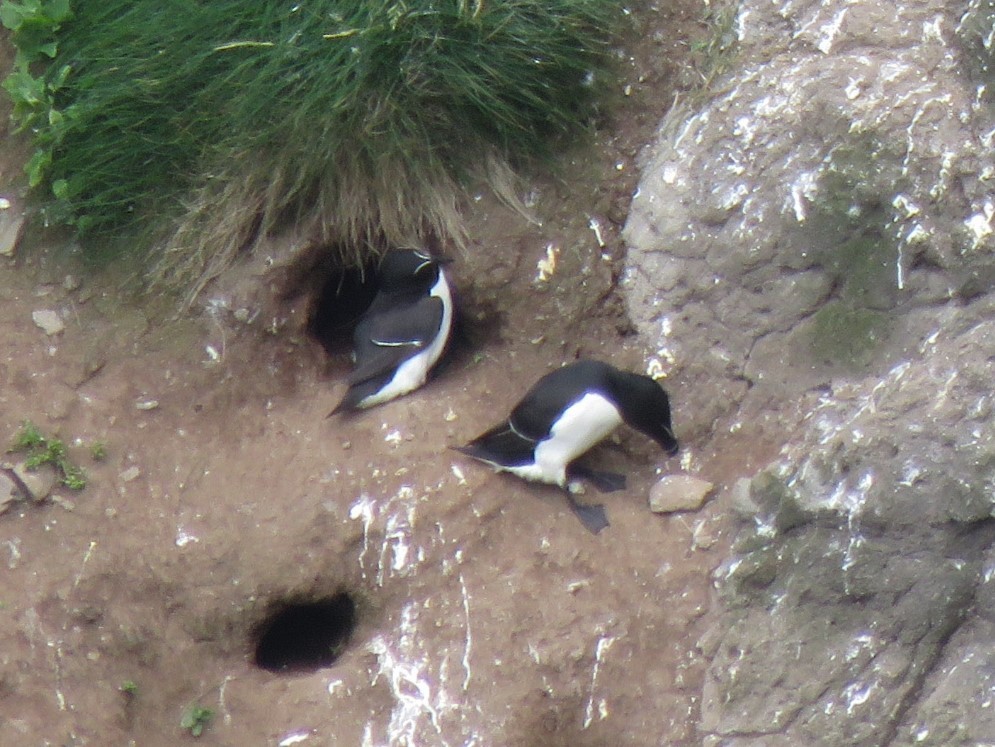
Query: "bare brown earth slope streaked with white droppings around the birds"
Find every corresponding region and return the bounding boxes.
[0,2,778,745]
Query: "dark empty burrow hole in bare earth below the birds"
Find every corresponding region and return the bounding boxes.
[255,592,356,672]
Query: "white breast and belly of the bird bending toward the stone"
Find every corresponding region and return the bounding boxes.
[508,394,622,487]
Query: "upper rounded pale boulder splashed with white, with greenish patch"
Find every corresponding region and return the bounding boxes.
[623,0,995,432]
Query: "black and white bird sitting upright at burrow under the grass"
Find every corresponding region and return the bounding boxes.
[329,249,453,415]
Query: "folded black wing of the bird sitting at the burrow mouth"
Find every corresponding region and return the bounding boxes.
[348,296,444,386]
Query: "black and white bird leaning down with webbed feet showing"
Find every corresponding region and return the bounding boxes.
[457,361,678,534]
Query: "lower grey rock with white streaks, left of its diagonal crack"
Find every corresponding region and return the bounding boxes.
[702,321,995,745]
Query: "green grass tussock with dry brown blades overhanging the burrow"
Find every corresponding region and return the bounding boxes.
[3,0,623,298]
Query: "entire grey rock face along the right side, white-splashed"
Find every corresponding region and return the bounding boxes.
[624,0,995,745]
